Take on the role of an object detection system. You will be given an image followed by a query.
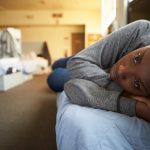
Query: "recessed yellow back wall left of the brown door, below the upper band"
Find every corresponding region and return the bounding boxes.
[20,25,84,61]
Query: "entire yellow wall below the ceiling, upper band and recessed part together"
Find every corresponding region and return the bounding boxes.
[0,10,100,60]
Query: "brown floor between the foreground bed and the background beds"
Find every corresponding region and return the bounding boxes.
[0,75,56,150]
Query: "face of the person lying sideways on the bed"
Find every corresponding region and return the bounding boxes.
[110,46,150,96]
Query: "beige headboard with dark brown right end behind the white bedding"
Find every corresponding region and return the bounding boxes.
[22,42,51,65]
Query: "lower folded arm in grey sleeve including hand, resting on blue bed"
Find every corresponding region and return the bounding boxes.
[65,79,150,122]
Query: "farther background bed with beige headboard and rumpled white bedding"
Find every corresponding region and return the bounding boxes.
[22,42,51,74]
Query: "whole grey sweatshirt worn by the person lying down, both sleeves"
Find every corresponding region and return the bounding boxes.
[64,20,150,116]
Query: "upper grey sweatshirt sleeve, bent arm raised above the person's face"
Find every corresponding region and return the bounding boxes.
[67,20,150,87]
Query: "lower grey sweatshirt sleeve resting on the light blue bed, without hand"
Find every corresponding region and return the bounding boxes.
[64,79,136,116]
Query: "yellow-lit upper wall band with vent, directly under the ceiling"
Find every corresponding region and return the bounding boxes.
[0,10,100,33]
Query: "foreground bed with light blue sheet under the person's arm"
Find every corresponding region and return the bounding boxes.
[56,92,150,150]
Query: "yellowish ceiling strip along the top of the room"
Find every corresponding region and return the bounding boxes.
[0,0,100,11]
